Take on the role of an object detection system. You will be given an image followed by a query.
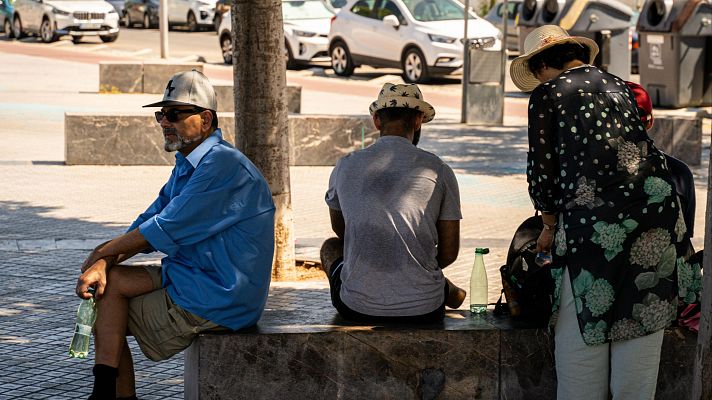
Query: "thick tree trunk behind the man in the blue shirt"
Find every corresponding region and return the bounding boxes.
[232,0,296,280]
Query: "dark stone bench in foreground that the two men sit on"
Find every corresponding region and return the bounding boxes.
[184,304,697,400]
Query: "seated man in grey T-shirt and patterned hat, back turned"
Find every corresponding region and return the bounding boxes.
[321,83,465,323]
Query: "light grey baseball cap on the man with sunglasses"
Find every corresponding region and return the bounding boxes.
[144,70,218,111]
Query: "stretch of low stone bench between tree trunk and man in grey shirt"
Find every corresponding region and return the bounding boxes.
[289,115,379,166]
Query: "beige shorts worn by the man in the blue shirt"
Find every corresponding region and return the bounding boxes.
[128,265,222,361]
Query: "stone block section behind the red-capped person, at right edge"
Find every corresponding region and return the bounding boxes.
[648,110,706,166]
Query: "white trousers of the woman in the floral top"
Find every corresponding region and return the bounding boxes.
[554,268,665,400]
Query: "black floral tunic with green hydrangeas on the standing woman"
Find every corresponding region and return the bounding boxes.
[527,65,686,345]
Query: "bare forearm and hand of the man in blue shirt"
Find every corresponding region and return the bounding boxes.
[76,228,150,299]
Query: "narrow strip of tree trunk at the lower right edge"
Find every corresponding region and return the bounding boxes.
[690,140,712,400]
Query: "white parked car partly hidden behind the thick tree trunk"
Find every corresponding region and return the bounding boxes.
[218,0,334,69]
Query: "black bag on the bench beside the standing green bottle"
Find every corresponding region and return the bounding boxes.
[495,215,554,327]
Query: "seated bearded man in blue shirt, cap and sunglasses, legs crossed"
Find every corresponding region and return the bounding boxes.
[76,70,275,400]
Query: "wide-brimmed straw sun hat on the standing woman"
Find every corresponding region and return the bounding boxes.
[509,25,598,92]
